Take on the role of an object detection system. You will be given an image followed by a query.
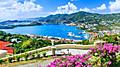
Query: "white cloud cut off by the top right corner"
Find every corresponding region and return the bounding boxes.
[109,0,120,12]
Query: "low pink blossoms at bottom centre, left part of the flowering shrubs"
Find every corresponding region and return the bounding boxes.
[47,54,91,67]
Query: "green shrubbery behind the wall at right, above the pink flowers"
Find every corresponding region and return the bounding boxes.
[76,34,120,45]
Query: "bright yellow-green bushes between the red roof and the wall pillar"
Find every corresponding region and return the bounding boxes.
[11,38,51,54]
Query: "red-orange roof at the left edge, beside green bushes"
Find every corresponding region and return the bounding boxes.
[0,41,14,54]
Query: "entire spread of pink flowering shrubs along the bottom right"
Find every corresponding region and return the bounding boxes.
[47,44,120,67]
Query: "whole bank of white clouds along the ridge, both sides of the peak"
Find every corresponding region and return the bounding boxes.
[51,2,107,14]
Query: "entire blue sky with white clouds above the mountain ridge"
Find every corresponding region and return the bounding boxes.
[0,0,120,21]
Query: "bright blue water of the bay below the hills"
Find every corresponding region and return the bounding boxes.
[1,24,89,40]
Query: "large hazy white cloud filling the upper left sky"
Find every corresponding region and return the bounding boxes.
[0,0,42,19]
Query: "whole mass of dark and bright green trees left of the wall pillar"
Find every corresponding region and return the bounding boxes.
[0,31,51,54]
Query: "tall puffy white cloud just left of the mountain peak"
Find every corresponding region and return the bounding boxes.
[51,2,77,14]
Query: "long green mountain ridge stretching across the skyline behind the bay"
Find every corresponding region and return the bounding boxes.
[0,11,120,24]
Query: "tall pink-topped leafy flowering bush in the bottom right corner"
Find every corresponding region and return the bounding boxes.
[90,44,120,66]
